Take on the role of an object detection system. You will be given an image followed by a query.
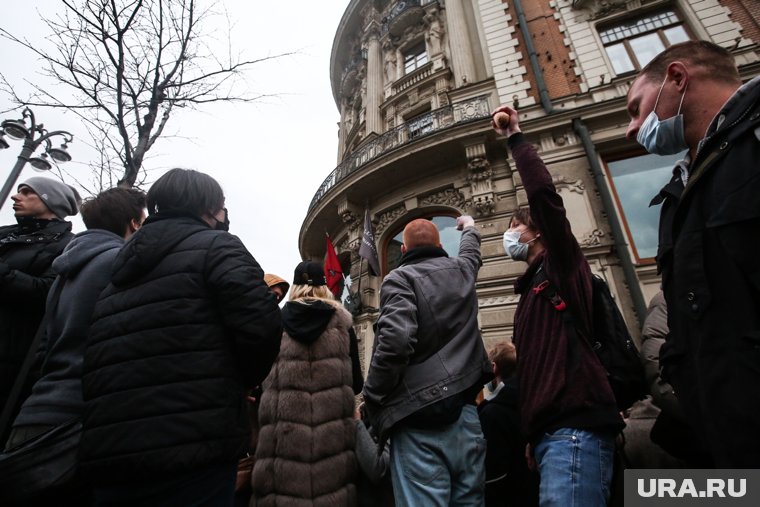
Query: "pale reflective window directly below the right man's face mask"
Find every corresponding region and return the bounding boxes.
[606,152,685,262]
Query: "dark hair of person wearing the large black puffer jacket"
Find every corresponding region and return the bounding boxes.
[148,169,224,217]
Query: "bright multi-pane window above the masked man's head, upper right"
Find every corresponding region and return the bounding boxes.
[599,11,690,75]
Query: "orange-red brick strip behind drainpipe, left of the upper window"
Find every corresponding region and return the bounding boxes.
[502,0,581,102]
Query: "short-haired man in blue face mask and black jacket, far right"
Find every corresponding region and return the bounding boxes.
[626,41,760,468]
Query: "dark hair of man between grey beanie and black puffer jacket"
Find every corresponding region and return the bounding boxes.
[79,187,145,237]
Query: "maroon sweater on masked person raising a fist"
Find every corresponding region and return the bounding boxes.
[508,134,623,444]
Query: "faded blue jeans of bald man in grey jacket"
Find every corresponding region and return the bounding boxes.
[391,405,486,507]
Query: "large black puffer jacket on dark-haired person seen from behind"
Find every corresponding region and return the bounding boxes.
[80,215,281,484]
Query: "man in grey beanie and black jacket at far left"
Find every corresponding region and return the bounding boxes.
[0,177,81,418]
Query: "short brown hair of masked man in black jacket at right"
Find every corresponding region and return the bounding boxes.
[639,40,741,84]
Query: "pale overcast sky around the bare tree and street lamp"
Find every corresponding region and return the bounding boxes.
[0,0,348,281]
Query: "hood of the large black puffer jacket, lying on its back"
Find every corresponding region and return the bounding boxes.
[111,213,211,285]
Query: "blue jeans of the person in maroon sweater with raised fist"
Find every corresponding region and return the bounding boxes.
[534,428,615,507]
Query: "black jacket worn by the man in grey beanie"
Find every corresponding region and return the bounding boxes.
[0,218,74,407]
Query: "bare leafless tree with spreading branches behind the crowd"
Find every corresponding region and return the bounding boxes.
[0,0,290,187]
